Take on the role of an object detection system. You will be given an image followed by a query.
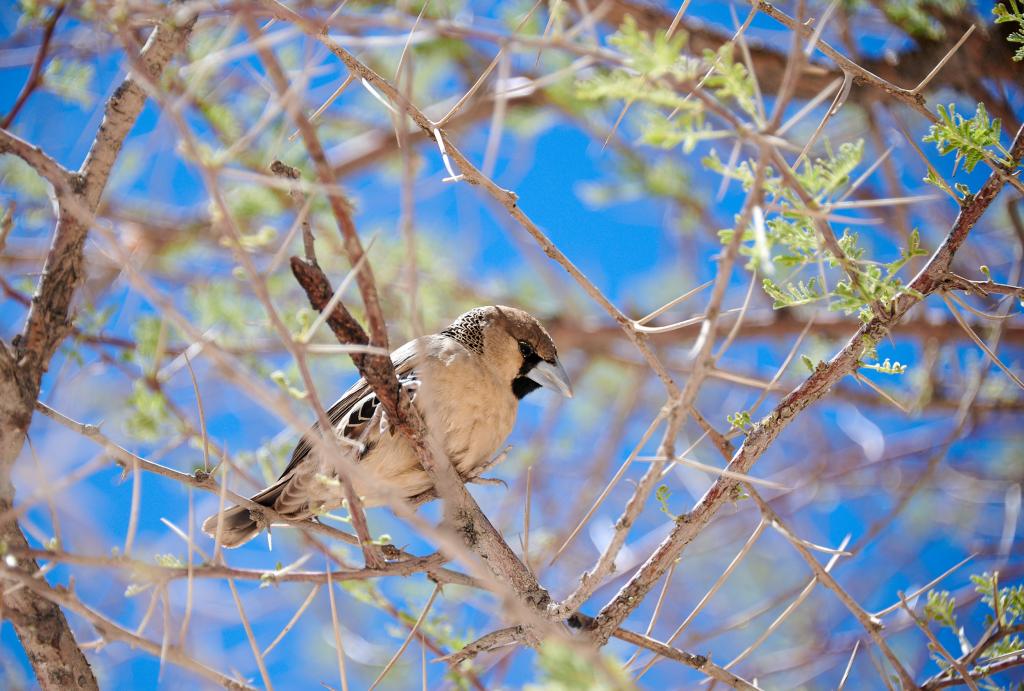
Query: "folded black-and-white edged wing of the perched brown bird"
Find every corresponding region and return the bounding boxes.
[281,341,420,479]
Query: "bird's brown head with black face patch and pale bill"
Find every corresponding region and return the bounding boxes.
[441,305,572,398]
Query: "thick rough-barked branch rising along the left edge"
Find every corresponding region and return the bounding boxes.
[0,12,194,689]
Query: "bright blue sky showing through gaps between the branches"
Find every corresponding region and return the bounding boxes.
[0,2,1024,689]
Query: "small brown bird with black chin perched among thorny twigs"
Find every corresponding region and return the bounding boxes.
[203,305,572,547]
